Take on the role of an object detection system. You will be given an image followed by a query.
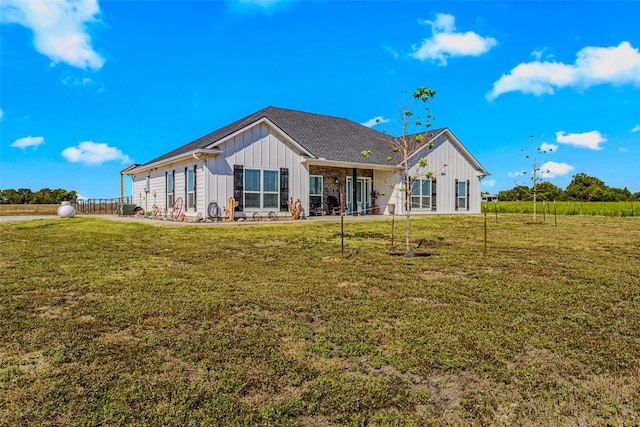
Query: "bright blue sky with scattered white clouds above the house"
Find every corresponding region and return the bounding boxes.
[0,0,640,197]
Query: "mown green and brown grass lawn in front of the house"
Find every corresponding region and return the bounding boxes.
[0,215,640,426]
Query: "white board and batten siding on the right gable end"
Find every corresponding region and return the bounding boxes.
[385,134,481,214]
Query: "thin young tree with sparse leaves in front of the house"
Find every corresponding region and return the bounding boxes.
[362,86,446,252]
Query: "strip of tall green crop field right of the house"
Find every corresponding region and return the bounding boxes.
[482,201,640,216]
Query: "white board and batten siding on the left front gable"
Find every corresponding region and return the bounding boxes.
[208,124,309,216]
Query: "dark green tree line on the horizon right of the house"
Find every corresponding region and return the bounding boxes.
[497,173,640,202]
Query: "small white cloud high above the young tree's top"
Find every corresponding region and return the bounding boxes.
[411,13,497,65]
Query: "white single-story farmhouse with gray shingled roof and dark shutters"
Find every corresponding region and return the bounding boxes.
[125,107,489,221]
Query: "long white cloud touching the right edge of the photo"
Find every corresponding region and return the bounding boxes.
[487,41,640,100]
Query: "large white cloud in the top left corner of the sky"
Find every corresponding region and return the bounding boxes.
[0,0,104,70]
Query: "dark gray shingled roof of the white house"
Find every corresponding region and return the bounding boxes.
[137,107,441,166]
